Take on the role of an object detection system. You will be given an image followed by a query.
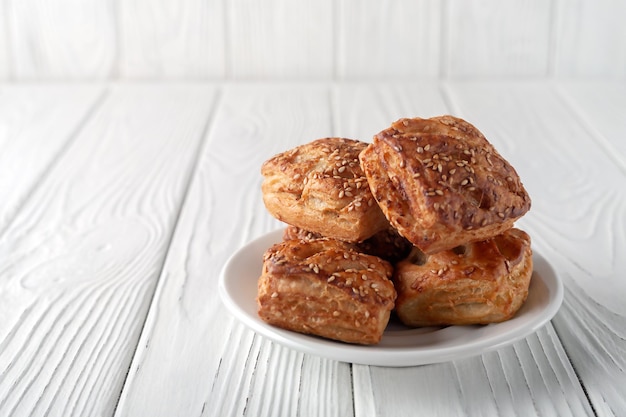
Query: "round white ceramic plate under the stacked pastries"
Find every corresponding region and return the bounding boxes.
[219,230,563,367]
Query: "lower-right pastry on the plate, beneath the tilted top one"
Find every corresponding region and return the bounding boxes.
[393,228,533,326]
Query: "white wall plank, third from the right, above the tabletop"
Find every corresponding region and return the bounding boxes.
[335,0,442,80]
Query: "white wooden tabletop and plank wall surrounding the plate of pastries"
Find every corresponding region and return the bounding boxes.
[0,0,626,417]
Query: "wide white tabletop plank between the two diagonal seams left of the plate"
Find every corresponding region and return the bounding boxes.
[0,85,217,416]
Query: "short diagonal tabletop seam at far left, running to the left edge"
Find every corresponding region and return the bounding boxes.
[0,88,109,238]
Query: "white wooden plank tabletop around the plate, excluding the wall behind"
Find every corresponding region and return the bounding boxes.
[0,80,626,417]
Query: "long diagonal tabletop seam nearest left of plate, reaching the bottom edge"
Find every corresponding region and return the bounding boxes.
[113,89,222,415]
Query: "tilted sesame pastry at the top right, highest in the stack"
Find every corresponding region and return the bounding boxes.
[360,116,531,253]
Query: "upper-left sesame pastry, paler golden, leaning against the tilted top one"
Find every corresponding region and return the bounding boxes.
[261,138,389,242]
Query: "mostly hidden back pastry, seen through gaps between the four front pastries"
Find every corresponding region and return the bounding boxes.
[283,226,413,264]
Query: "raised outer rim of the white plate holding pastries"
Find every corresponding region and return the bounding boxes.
[218,228,564,367]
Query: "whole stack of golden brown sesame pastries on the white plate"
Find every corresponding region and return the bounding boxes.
[257,115,533,344]
